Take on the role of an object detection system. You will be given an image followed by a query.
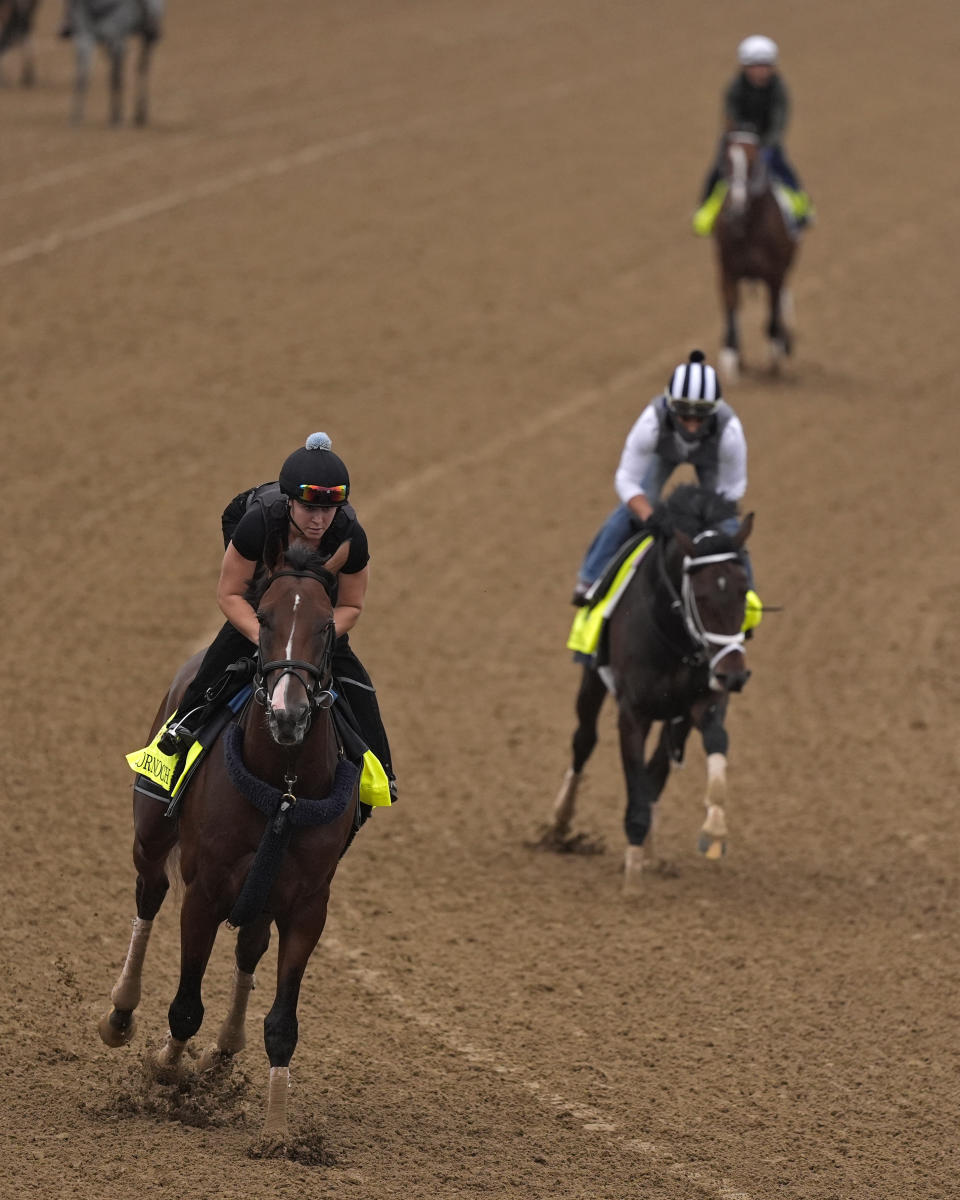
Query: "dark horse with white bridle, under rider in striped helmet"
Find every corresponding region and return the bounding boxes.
[541,484,754,892]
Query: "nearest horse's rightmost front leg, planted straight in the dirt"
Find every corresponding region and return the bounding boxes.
[263,912,330,1146]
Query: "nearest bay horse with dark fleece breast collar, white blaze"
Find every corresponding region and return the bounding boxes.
[98,542,359,1150]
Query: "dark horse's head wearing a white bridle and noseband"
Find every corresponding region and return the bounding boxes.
[673,512,754,692]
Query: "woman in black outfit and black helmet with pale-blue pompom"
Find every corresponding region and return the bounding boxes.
[157,433,394,792]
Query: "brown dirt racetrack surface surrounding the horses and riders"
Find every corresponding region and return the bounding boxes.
[0,0,960,1200]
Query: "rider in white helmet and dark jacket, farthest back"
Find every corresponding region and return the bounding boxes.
[694,34,812,235]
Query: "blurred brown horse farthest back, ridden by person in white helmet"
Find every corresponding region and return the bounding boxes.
[713,130,797,382]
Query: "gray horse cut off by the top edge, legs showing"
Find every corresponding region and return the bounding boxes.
[61,0,166,125]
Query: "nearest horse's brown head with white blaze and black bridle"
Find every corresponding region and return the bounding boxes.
[256,542,349,746]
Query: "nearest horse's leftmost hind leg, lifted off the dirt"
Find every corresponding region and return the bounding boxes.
[97,792,178,1048]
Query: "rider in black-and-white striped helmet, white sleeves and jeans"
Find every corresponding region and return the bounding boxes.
[574,350,752,605]
